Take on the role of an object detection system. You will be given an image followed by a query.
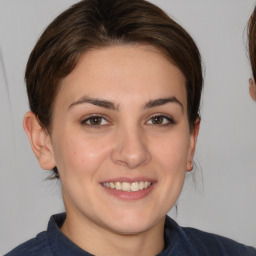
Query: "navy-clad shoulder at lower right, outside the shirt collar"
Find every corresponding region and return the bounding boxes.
[182,228,256,256]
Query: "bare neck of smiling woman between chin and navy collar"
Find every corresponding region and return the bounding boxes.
[61,214,165,256]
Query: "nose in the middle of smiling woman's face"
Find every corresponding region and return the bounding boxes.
[112,127,151,169]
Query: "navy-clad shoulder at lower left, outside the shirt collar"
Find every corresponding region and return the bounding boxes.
[5,232,52,256]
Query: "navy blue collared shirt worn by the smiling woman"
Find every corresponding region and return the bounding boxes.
[5,213,256,256]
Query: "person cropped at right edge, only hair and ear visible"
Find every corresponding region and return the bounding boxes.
[248,5,256,100]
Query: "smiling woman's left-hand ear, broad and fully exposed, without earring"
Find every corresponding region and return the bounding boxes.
[23,111,56,170]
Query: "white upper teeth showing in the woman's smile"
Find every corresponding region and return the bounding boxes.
[103,181,152,192]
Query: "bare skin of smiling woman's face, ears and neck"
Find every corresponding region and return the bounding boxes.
[24,45,199,255]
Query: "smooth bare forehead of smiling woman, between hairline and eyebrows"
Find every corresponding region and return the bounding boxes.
[57,45,186,107]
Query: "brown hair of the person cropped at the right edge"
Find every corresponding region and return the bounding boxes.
[247,7,256,81]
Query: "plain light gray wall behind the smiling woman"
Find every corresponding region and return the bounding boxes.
[0,0,256,254]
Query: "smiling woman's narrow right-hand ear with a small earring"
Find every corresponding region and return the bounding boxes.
[187,117,201,171]
